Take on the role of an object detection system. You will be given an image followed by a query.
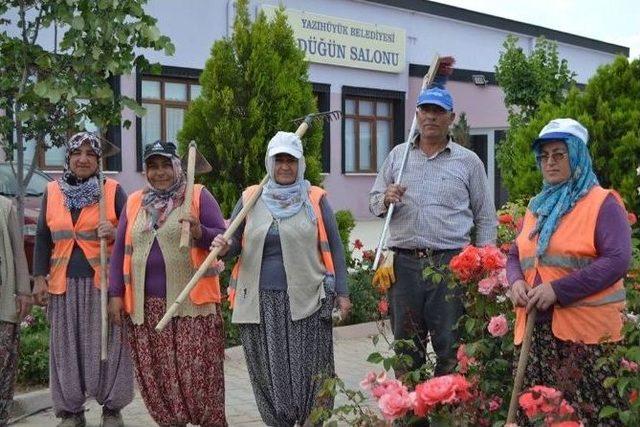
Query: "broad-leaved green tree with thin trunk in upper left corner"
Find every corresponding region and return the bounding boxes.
[0,0,174,226]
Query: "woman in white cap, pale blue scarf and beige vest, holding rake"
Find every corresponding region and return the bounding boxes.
[212,132,351,426]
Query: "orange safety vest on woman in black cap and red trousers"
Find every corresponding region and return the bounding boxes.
[122,184,220,314]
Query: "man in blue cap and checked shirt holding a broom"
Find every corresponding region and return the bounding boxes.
[369,81,497,376]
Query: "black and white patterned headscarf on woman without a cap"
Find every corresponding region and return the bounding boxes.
[58,132,102,210]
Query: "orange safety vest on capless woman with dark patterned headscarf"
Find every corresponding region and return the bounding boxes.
[46,178,118,295]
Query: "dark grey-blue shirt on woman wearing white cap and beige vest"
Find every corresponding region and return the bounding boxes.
[225,197,349,296]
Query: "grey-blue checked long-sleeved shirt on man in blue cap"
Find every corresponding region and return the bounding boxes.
[369,136,497,250]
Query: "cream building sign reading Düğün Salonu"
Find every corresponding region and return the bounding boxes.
[262,5,406,73]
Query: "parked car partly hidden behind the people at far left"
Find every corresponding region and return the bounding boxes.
[0,163,52,273]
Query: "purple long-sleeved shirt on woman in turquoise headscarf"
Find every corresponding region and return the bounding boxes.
[507,195,631,322]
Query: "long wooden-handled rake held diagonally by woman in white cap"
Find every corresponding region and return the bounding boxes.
[156,111,342,332]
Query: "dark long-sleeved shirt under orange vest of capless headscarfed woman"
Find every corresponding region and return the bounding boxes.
[33,185,127,278]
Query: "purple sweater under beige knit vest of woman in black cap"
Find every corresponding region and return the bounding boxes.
[109,189,226,298]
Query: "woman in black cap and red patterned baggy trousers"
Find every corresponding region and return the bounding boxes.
[109,141,226,426]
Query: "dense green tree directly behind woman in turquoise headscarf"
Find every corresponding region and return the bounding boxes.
[501,56,640,212]
